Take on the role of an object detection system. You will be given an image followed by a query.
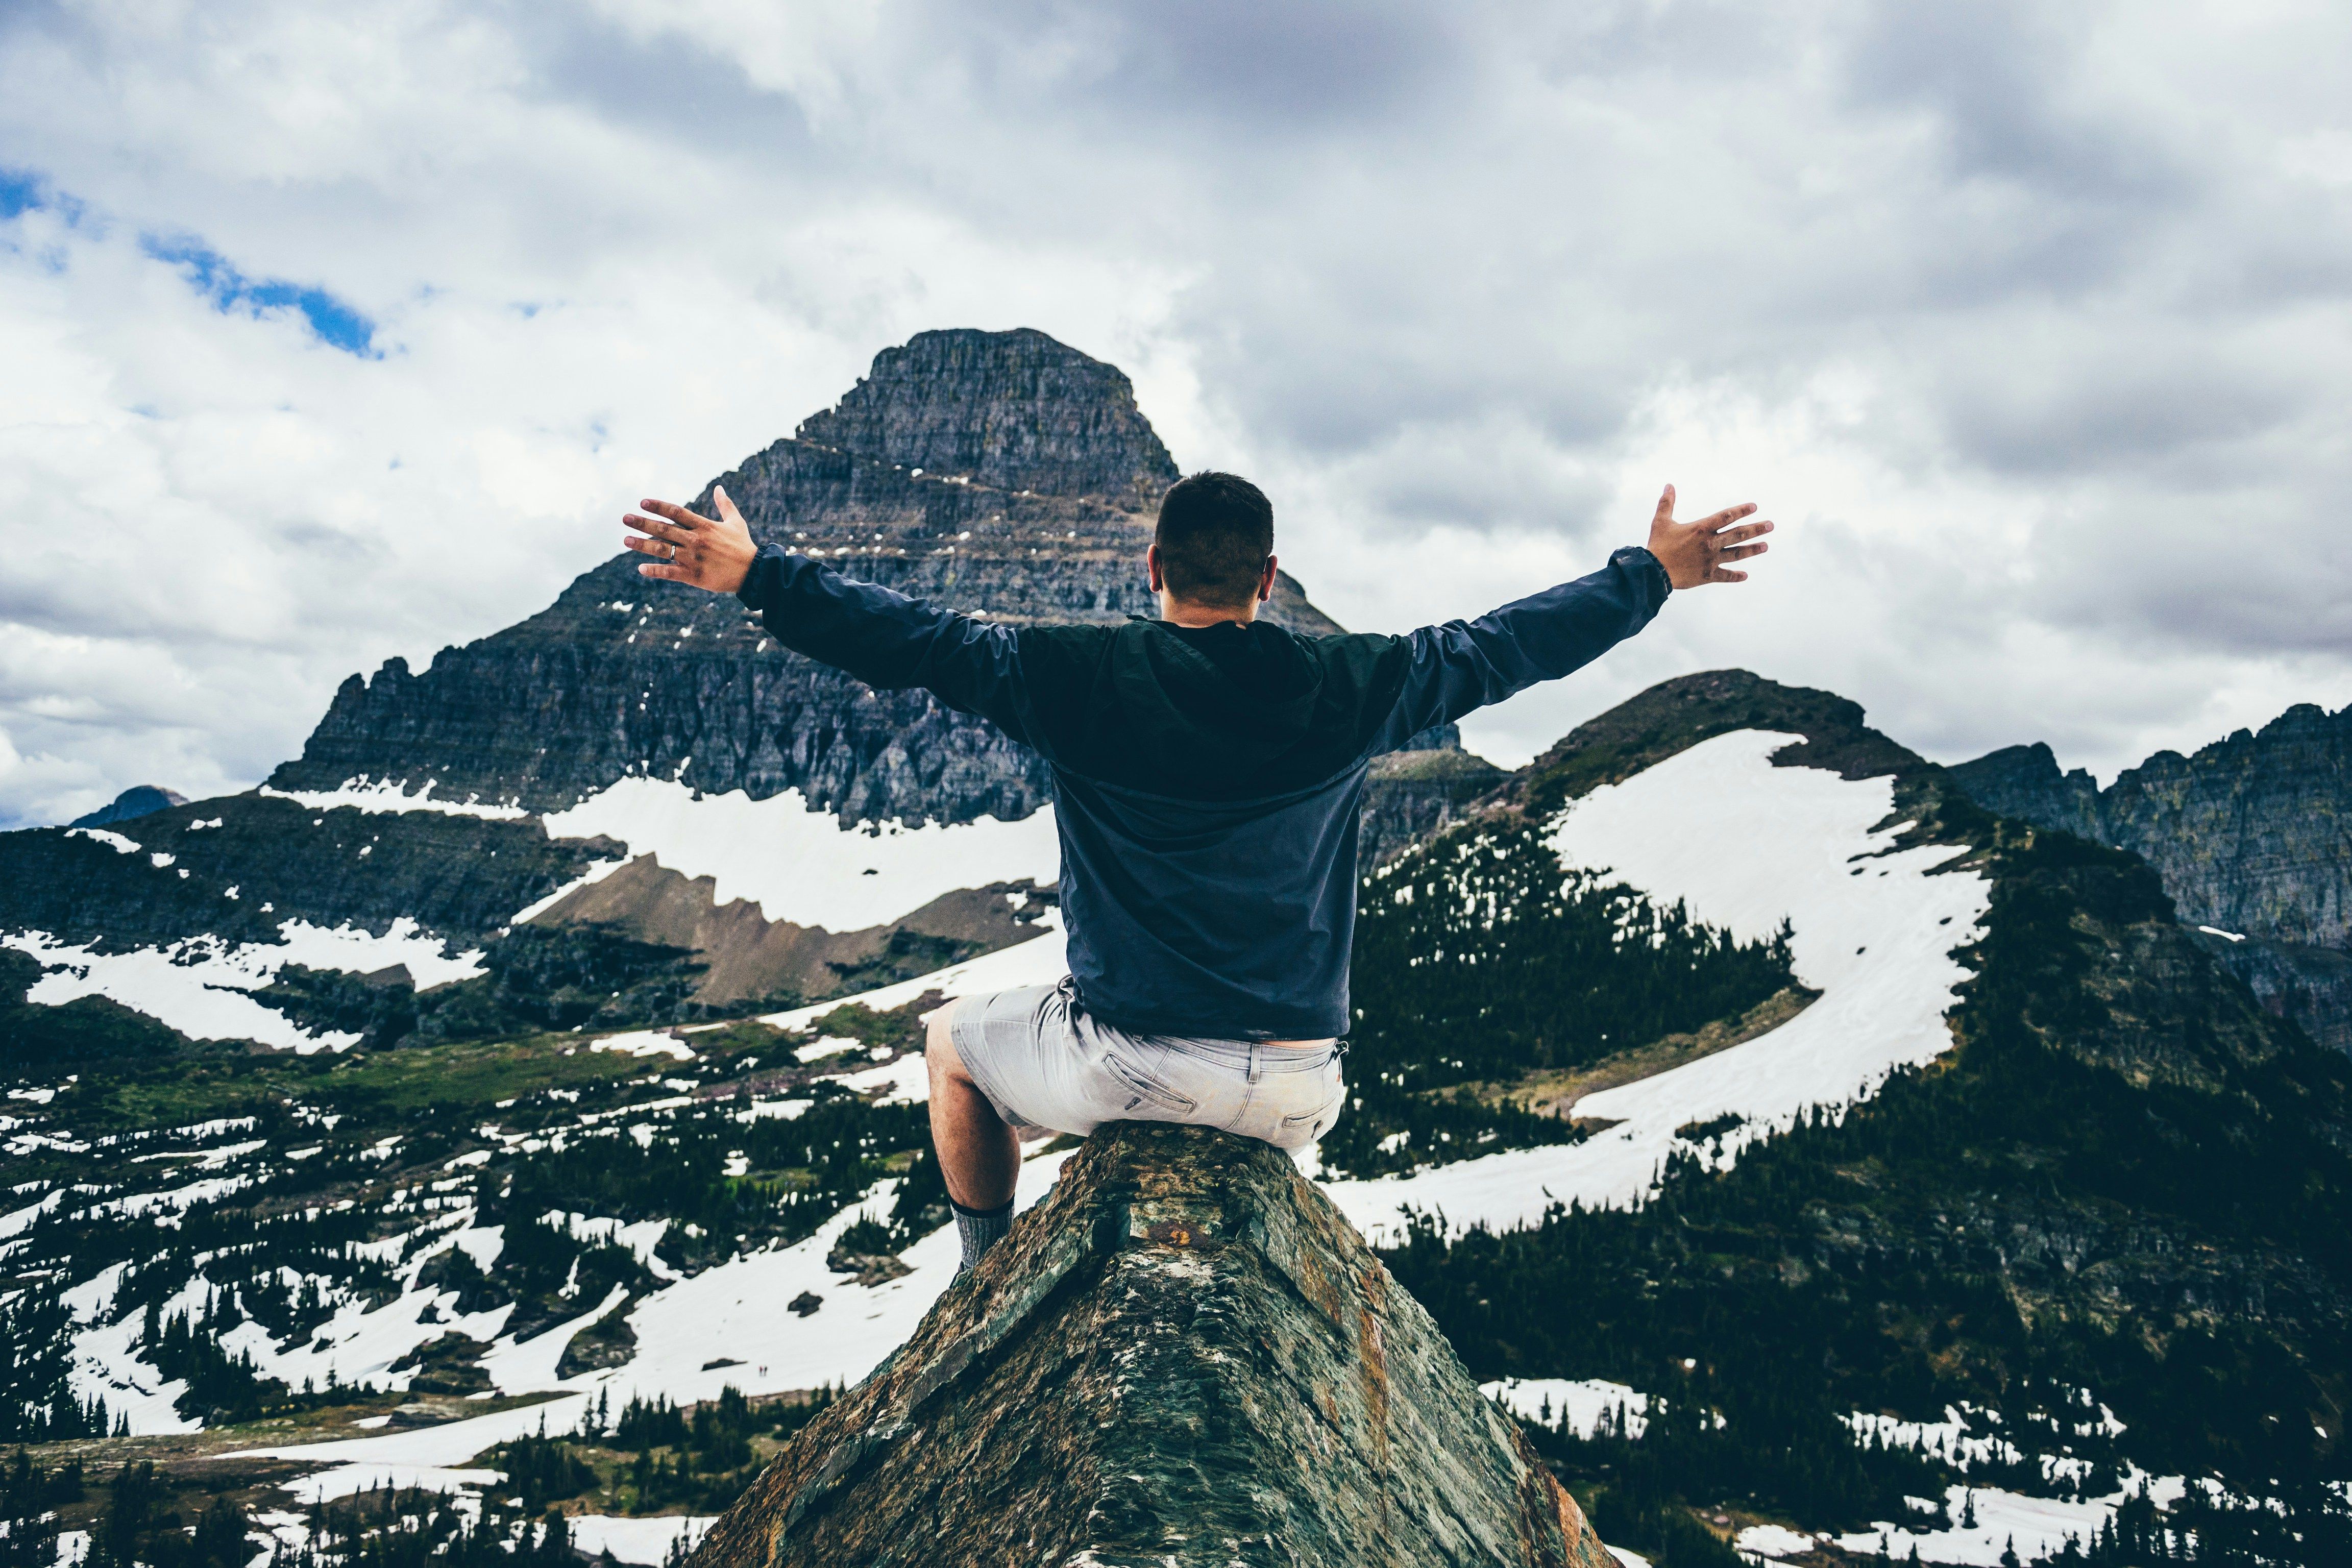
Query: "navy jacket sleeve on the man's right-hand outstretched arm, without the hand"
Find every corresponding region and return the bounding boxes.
[1374,546,1670,752]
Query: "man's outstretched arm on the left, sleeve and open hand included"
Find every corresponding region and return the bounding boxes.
[621,489,1025,741]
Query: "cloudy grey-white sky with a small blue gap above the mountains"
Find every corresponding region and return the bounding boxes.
[0,0,2352,825]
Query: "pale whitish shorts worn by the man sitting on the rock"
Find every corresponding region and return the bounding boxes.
[948,981,1348,1149]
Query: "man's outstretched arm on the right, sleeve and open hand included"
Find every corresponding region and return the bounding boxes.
[1381,484,1771,750]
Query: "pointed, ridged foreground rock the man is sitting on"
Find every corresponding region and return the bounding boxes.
[692,1124,1613,1568]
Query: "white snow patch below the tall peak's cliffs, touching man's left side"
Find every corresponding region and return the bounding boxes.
[543,778,1061,931]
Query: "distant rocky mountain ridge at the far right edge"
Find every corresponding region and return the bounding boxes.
[1952,703,2352,1051]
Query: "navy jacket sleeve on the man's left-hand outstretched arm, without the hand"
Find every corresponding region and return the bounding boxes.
[736,546,1028,743]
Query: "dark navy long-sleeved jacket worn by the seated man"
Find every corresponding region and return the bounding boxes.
[739,546,1668,1039]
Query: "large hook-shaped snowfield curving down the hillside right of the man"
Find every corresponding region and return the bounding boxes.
[1324,729,1992,1241]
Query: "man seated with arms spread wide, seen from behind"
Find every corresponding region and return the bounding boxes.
[623,473,1771,1267]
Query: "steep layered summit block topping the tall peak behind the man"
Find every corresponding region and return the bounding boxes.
[795,327,1176,498]
